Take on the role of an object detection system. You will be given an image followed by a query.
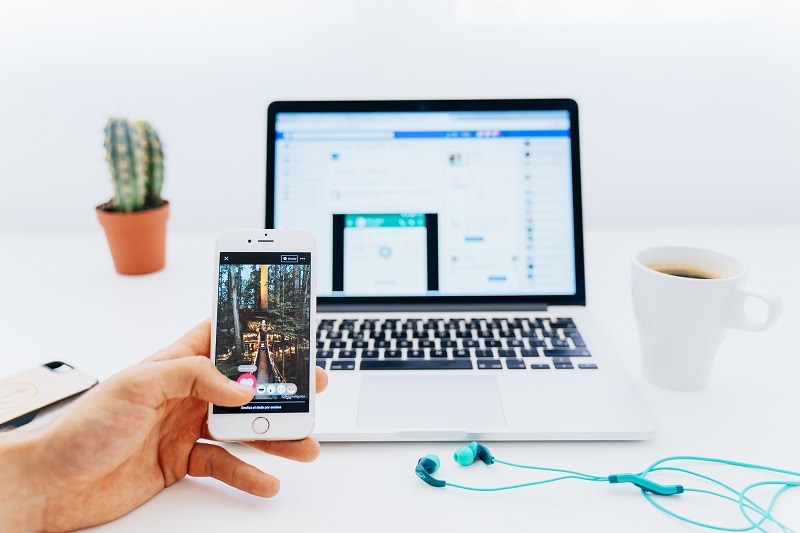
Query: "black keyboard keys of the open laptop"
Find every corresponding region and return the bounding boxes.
[317,317,597,370]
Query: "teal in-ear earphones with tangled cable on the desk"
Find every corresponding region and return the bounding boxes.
[415,441,800,532]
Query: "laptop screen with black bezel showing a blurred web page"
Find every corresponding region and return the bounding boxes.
[266,100,583,305]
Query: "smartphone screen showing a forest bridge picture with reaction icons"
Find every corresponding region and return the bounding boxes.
[213,252,313,414]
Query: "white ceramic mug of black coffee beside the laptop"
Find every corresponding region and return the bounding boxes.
[631,246,782,391]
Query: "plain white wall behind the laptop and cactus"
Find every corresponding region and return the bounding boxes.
[0,0,800,232]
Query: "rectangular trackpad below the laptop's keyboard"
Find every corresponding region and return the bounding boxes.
[357,375,506,431]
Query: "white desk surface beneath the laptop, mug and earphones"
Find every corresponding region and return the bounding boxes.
[0,226,800,533]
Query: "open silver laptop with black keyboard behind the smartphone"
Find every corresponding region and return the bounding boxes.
[265,99,655,441]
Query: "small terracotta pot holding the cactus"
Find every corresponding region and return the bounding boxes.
[96,201,169,275]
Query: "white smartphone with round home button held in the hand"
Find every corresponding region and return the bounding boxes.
[208,229,317,441]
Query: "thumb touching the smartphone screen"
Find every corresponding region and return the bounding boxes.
[132,355,254,407]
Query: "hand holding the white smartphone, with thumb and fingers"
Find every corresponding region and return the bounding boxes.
[3,320,328,531]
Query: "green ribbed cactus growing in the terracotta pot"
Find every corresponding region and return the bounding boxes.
[105,118,164,212]
